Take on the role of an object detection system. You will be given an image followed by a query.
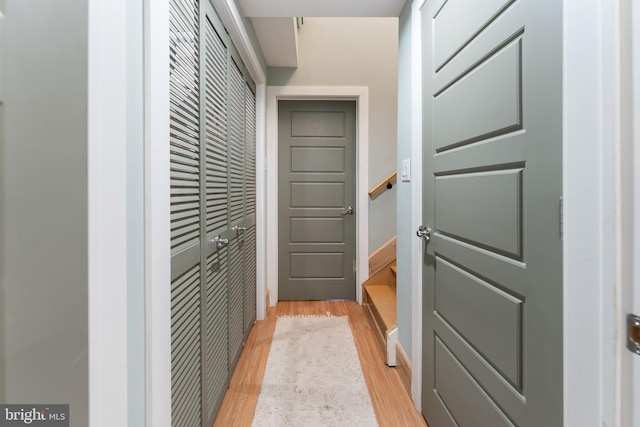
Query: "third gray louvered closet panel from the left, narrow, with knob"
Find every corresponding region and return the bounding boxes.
[228,58,245,369]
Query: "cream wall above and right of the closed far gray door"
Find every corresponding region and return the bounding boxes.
[268,18,398,253]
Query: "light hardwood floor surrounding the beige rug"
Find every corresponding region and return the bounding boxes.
[214,301,427,427]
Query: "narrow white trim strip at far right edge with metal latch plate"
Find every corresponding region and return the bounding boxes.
[616,0,640,426]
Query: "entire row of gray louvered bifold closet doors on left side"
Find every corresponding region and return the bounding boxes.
[169,0,256,427]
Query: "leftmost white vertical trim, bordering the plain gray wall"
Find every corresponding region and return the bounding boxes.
[87,0,128,427]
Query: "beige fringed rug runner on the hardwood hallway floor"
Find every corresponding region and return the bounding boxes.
[252,314,378,427]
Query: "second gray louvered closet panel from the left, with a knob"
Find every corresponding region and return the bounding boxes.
[202,3,230,426]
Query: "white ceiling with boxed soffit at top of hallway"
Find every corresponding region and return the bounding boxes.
[239,0,406,67]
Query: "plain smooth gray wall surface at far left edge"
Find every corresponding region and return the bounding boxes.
[0,0,89,427]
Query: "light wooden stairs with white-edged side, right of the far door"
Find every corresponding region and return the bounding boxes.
[363,247,398,366]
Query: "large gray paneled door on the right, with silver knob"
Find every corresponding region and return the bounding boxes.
[421,0,563,427]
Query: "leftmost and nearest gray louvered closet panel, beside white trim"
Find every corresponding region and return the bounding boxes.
[169,0,202,427]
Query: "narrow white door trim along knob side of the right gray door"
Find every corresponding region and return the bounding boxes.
[411,0,425,411]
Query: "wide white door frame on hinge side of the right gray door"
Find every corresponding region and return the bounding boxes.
[563,0,621,426]
